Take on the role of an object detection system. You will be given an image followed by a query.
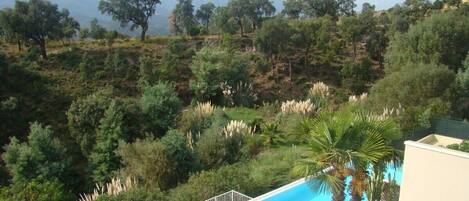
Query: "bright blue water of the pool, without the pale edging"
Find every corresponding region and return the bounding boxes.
[264,165,402,201]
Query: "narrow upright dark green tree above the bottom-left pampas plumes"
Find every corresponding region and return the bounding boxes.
[90,101,124,184]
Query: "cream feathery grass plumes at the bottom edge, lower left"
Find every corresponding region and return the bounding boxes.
[79,177,137,201]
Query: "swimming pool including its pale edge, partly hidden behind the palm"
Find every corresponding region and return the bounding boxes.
[254,164,402,201]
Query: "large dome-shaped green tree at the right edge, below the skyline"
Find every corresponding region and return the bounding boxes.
[385,11,469,72]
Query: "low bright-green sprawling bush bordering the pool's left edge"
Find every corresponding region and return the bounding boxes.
[168,148,304,201]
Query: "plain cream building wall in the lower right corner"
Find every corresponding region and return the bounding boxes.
[399,141,469,201]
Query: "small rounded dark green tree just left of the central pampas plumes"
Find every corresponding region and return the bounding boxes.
[140,82,182,136]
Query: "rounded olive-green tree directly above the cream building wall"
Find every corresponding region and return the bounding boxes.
[370,63,455,124]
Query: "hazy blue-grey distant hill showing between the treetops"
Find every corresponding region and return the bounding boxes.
[0,0,403,35]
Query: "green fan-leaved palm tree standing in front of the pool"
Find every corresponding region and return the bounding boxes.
[294,111,400,201]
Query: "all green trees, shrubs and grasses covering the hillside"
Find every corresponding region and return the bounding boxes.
[0,0,469,201]
